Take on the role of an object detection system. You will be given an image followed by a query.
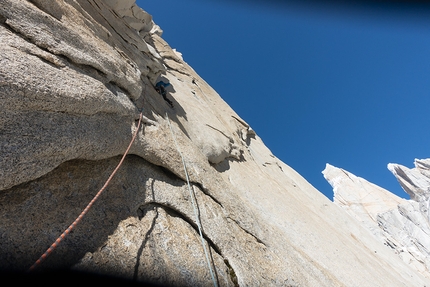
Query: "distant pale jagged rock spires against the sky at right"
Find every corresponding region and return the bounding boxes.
[323,159,430,278]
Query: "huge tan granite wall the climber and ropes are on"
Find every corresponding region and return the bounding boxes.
[0,0,429,286]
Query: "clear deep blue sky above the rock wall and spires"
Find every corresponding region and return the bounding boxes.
[137,0,430,198]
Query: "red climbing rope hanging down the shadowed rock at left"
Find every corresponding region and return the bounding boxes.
[29,113,143,271]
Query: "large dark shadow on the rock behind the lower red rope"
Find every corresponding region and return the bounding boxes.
[0,155,163,272]
